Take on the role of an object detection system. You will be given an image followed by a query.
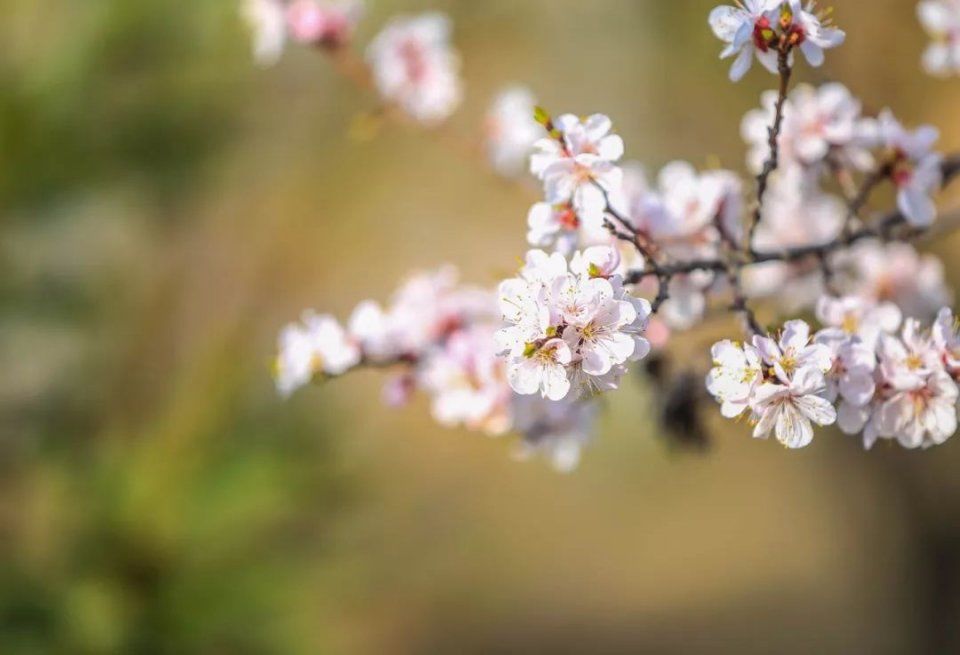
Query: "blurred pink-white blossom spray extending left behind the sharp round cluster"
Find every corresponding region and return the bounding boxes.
[274,267,595,470]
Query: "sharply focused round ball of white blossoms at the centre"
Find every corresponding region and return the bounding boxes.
[497,246,650,401]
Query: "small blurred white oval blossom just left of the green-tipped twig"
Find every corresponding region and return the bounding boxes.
[484,86,543,177]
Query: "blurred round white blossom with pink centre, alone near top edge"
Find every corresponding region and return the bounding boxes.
[367,13,463,124]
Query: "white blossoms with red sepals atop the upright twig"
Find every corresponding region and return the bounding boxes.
[709,0,846,82]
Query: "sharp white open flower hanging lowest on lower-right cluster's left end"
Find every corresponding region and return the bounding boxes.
[750,367,837,448]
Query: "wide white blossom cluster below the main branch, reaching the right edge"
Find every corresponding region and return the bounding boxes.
[707,297,960,448]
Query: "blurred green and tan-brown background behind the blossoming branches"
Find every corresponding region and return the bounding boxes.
[0,0,960,655]
